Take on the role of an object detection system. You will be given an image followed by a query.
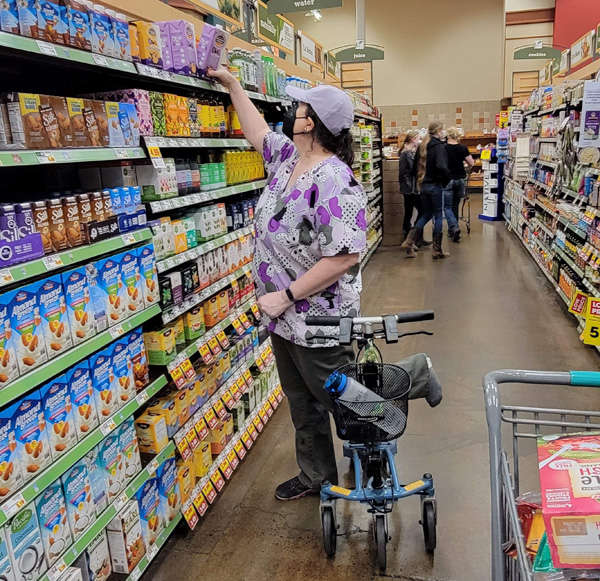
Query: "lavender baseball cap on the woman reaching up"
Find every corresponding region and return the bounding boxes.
[285,85,354,136]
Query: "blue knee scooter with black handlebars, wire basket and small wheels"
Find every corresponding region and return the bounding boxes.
[306,311,437,570]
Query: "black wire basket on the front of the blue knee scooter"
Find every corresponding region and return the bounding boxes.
[331,363,411,443]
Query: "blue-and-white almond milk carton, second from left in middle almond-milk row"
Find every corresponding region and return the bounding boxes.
[13,391,52,481]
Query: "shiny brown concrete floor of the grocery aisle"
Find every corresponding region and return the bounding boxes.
[147,197,600,581]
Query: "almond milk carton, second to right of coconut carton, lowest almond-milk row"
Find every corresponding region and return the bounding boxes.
[61,460,96,540]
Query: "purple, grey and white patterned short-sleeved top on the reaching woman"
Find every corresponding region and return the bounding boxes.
[253,133,367,347]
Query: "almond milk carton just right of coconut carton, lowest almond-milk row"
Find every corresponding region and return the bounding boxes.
[35,480,73,567]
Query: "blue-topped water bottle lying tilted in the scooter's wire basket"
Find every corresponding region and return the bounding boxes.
[324,371,405,434]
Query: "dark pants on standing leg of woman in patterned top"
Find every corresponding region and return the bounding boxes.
[270,333,354,488]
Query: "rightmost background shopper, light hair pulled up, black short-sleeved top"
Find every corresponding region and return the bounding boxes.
[444,127,475,242]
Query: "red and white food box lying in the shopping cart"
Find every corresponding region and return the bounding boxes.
[538,432,600,569]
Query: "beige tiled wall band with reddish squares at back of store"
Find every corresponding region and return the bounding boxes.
[380,101,500,132]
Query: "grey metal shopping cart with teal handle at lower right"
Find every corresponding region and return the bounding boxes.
[483,369,600,581]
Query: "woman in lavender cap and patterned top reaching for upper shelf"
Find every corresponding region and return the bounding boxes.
[210,67,367,500]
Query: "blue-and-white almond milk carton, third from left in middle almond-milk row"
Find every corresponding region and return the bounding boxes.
[40,374,77,462]
